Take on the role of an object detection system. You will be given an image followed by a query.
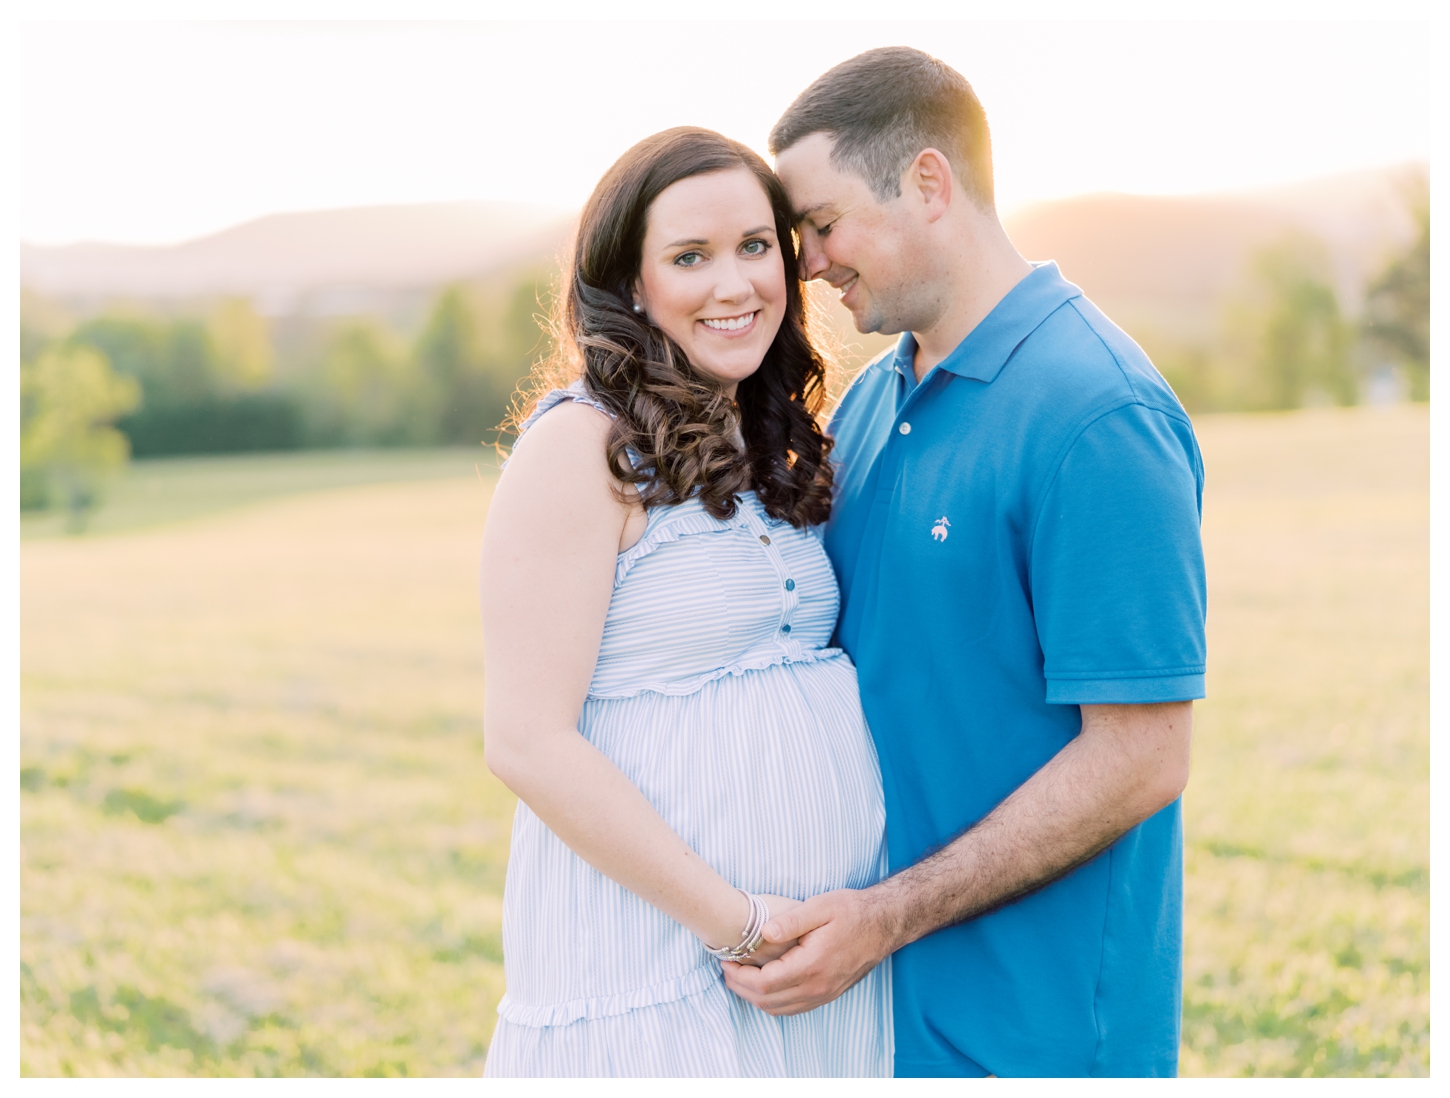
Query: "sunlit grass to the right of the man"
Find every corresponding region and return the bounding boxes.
[1182,406,1430,1075]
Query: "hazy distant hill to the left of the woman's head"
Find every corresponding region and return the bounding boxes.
[20,202,574,313]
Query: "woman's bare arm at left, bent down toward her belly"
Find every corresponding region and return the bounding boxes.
[483,405,793,962]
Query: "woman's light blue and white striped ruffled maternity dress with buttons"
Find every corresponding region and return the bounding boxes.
[484,383,892,1076]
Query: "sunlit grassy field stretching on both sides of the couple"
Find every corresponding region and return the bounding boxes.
[20,408,1430,1075]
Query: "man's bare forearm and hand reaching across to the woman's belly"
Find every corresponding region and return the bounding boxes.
[725,702,1193,1014]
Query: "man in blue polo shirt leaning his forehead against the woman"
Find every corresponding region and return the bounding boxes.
[726,48,1205,1076]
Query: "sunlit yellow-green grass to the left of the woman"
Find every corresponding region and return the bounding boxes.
[20,458,513,1076]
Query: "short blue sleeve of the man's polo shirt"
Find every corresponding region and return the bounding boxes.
[1030,405,1206,705]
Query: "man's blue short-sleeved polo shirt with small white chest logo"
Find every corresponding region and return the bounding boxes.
[825,264,1205,1076]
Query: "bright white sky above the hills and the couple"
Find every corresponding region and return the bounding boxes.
[12,18,1441,244]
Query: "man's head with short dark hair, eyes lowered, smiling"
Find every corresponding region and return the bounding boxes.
[770,46,996,332]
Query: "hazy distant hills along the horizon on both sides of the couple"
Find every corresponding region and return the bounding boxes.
[20,165,1428,352]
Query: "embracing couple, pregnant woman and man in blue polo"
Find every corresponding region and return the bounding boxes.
[483,48,1205,1076]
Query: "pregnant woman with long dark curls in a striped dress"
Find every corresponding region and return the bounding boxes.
[483,129,892,1076]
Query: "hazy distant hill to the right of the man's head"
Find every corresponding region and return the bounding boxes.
[1006,158,1427,341]
